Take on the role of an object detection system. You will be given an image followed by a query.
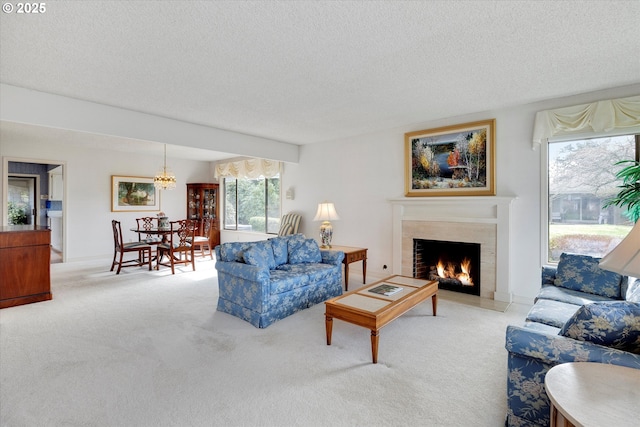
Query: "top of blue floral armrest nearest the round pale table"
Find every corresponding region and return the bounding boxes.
[505,325,640,369]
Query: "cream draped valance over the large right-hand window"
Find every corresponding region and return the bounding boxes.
[533,95,640,149]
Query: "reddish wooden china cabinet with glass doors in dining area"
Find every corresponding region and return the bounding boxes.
[187,184,220,246]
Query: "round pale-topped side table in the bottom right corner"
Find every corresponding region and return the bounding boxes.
[544,362,640,427]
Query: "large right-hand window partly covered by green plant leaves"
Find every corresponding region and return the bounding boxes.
[546,135,640,263]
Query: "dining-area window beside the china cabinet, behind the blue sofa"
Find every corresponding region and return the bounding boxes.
[224,175,280,234]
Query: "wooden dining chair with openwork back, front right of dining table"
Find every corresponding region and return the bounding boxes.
[156,219,196,274]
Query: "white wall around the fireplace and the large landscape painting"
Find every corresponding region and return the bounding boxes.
[283,85,640,303]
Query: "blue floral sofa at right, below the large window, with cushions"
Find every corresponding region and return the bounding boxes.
[505,254,640,427]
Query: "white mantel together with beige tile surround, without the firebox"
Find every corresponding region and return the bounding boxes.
[390,196,516,303]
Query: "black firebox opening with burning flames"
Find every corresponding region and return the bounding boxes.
[413,239,480,296]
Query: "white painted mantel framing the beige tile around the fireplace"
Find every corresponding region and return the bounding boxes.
[389,196,516,302]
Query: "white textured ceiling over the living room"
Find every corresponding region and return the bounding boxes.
[0,0,640,160]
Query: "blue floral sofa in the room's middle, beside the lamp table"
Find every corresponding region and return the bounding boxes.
[215,234,344,328]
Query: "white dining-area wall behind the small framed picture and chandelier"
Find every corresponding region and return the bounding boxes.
[0,138,215,261]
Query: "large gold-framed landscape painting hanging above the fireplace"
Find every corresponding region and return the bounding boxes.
[404,119,496,197]
